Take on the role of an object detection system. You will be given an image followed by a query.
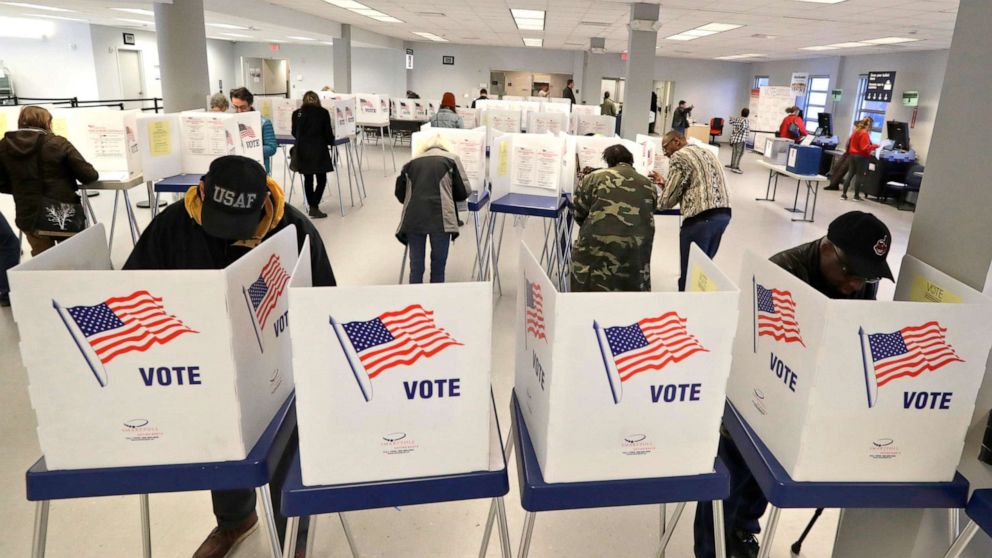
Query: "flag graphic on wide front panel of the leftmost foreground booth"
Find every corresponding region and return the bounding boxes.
[65,291,198,364]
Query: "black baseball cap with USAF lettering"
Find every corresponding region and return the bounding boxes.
[200,155,269,240]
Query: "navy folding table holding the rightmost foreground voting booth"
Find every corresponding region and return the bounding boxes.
[723,401,968,558]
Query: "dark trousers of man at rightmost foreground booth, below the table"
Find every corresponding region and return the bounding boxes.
[693,436,768,558]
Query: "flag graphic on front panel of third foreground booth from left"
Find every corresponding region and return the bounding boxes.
[603,312,707,382]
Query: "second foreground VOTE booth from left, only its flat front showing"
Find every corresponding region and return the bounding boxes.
[290,282,499,486]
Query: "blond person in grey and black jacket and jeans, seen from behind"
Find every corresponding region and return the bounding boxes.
[395,135,471,284]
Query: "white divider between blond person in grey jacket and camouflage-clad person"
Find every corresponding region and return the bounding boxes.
[489,134,568,200]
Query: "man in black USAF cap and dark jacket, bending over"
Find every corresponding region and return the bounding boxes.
[124,155,337,558]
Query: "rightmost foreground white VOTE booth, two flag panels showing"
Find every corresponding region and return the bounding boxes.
[727,253,992,482]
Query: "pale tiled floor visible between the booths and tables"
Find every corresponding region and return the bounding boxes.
[0,139,913,558]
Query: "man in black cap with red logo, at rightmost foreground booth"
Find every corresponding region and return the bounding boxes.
[695,211,892,558]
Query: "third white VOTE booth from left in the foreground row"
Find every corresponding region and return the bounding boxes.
[514,245,739,483]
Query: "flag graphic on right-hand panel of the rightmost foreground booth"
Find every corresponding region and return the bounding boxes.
[868,322,964,387]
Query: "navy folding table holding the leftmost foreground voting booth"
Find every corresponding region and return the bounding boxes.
[26,395,296,558]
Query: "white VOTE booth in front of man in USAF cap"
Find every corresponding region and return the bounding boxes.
[9,225,297,469]
